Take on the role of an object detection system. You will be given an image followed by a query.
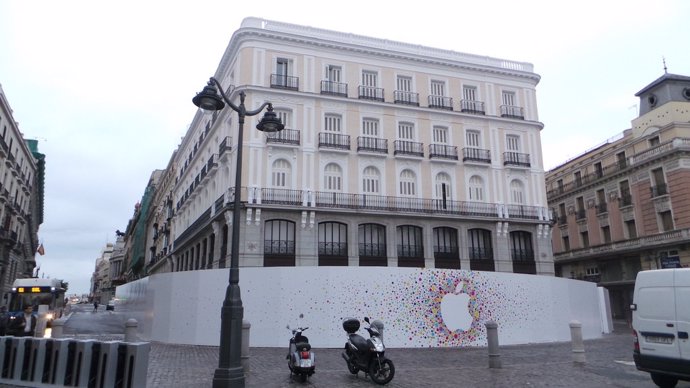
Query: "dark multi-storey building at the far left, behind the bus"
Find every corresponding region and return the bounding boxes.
[0,86,45,295]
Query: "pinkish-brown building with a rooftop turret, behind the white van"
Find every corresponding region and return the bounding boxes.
[546,74,690,318]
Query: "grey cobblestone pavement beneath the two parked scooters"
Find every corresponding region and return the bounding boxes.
[142,326,690,388]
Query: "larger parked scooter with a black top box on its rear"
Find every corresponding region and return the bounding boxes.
[342,317,395,385]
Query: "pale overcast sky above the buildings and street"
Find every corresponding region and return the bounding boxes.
[0,0,690,293]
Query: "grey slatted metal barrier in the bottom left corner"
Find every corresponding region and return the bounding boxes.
[0,336,151,388]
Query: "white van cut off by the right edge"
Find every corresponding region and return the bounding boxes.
[630,268,690,388]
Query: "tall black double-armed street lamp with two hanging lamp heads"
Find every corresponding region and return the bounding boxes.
[192,77,285,388]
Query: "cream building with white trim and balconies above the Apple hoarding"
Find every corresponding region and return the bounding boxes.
[148,18,553,275]
